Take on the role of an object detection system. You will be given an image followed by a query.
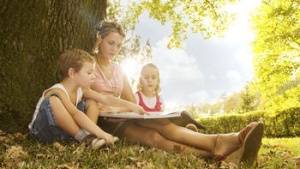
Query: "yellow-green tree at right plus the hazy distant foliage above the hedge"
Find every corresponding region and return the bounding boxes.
[184,0,300,117]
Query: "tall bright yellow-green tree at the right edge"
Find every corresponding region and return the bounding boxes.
[252,0,300,111]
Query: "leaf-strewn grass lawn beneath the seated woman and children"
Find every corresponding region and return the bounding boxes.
[0,132,300,169]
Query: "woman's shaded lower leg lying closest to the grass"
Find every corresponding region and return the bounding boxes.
[123,124,212,157]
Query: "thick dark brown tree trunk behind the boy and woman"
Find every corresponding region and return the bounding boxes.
[0,0,107,130]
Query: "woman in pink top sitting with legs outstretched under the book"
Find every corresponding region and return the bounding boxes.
[86,21,263,165]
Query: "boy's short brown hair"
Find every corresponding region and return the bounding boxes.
[58,49,95,80]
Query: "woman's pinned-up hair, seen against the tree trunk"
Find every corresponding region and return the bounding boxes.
[93,21,125,55]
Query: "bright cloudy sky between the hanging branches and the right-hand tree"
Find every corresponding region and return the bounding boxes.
[120,0,260,107]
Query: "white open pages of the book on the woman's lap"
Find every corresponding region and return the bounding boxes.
[99,111,181,119]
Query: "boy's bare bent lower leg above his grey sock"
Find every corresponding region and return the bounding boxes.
[49,96,80,137]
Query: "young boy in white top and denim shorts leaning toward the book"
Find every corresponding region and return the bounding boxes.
[28,49,145,149]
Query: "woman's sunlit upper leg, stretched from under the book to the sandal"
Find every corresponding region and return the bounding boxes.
[139,119,248,155]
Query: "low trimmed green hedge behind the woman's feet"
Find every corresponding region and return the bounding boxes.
[197,107,300,138]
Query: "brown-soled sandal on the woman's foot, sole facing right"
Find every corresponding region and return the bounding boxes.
[224,122,264,166]
